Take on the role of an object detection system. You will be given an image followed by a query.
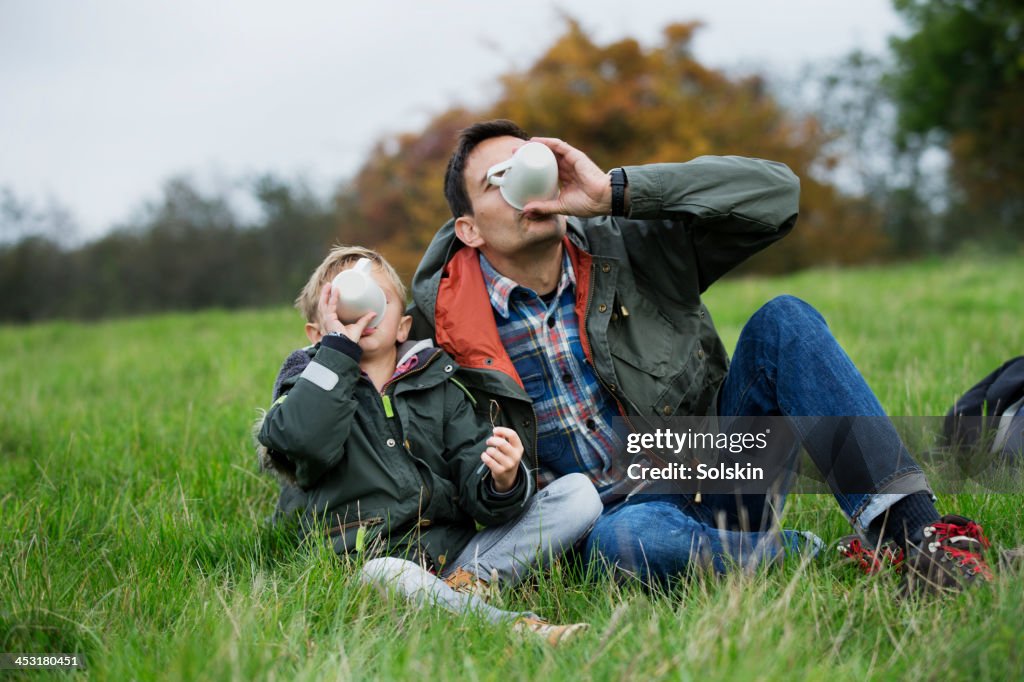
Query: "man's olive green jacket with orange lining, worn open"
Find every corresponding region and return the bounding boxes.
[410,157,800,481]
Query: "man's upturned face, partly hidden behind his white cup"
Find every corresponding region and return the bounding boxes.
[457,136,565,257]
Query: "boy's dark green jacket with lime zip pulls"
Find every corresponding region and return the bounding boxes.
[257,336,534,569]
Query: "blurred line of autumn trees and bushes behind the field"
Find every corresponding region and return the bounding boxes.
[0,0,1024,322]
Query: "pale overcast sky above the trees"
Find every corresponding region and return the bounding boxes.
[0,0,902,236]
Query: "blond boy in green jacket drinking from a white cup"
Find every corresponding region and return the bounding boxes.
[257,247,601,644]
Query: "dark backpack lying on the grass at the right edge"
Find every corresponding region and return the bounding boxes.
[942,355,1024,457]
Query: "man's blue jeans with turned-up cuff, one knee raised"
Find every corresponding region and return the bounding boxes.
[587,296,929,581]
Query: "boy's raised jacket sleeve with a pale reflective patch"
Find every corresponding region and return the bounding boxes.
[257,336,362,489]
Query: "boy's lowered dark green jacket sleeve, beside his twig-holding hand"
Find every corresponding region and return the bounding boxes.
[444,383,534,525]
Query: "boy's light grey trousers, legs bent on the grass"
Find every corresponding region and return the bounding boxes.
[360,473,601,623]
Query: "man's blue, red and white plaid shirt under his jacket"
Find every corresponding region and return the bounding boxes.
[480,253,621,487]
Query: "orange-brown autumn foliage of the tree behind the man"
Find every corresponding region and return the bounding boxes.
[339,19,884,276]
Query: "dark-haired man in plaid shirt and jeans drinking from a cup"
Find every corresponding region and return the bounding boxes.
[412,121,991,587]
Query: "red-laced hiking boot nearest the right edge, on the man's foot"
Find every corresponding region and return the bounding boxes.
[905,514,992,592]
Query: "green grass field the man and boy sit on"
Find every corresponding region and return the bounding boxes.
[0,251,1024,680]
